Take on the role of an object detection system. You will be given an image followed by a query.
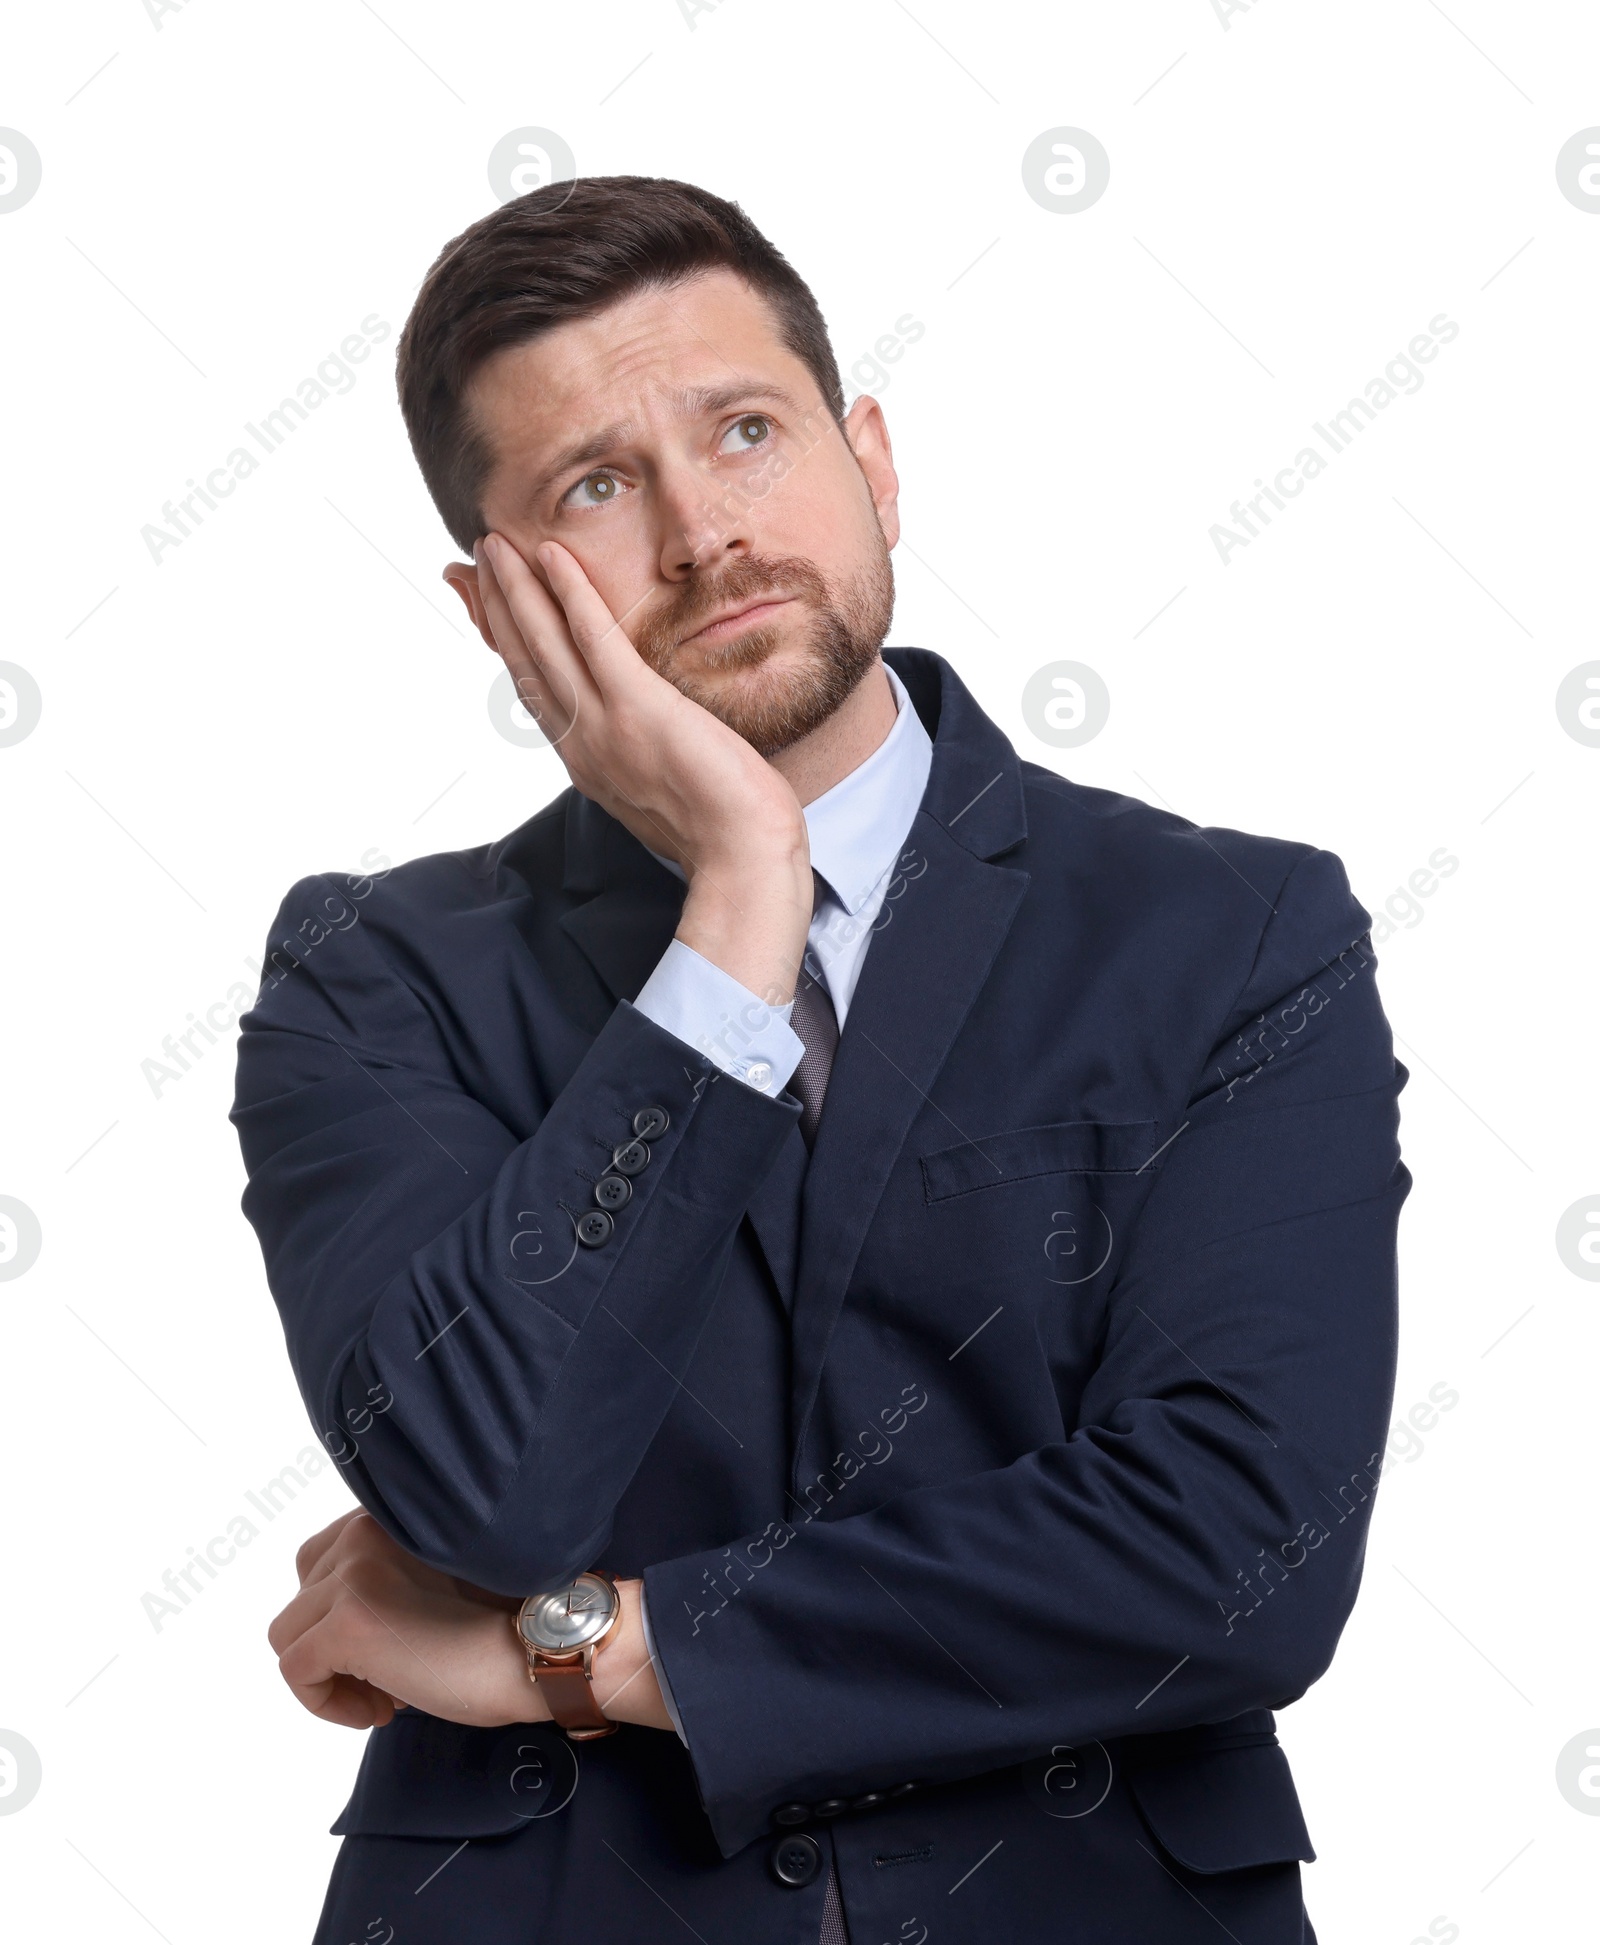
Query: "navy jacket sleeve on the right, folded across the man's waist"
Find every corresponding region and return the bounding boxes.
[645,854,1409,1856]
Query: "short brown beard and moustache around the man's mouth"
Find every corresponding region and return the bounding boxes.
[630,533,894,757]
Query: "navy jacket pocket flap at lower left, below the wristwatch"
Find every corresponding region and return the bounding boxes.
[332,1710,577,1836]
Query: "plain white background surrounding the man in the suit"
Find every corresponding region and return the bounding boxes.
[0,0,1600,1945]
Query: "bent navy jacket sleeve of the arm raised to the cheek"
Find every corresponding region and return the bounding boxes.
[231,877,797,1595]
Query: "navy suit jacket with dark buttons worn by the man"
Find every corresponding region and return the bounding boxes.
[233,650,1409,1945]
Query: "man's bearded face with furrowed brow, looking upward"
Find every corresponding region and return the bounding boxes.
[469,270,900,755]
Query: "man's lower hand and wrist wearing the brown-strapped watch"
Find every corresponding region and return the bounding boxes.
[266,1511,671,1729]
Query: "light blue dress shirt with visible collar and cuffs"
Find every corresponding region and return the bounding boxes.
[634,663,933,1743]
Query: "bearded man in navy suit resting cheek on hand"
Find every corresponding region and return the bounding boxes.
[233,177,1409,1945]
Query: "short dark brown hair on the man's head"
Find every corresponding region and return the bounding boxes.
[397,175,844,554]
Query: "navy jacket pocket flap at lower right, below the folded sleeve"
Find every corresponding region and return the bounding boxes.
[1128,1743,1316,1875]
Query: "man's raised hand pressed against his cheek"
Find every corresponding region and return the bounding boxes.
[474,533,813,1006]
